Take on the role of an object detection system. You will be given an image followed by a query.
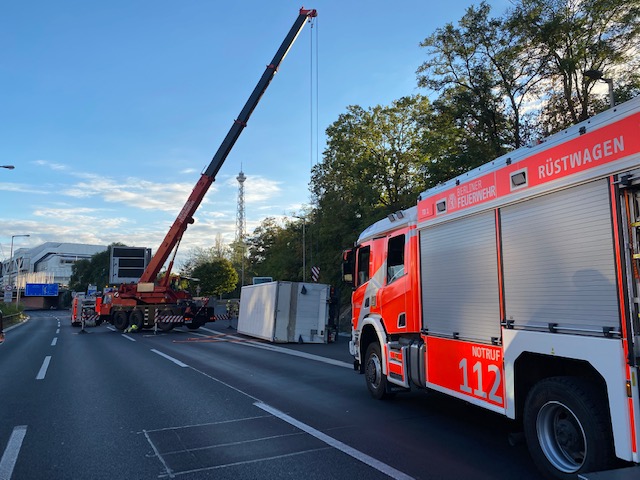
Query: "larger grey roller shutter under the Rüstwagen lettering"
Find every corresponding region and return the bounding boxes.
[500,180,620,335]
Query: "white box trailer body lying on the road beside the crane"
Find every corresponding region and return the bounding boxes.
[238,282,330,343]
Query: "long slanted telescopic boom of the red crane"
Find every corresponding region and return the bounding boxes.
[140,8,317,283]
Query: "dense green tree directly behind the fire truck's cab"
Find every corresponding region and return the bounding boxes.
[304,95,431,284]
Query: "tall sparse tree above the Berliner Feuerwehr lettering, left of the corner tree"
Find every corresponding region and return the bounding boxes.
[417,1,542,153]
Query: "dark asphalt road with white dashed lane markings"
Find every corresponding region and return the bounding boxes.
[0,311,539,480]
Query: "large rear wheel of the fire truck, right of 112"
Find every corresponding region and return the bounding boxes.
[523,377,614,480]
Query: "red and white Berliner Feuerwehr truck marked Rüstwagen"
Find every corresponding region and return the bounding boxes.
[343,97,640,479]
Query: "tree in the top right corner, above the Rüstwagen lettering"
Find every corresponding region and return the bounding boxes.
[508,0,640,133]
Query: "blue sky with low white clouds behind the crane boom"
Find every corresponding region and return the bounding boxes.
[0,0,508,264]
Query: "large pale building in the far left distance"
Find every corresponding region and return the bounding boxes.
[0,242,107,289]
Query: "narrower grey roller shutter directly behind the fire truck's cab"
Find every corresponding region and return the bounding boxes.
[420,211,500,343]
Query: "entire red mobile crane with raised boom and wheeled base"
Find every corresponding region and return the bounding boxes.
[96,8,317,330]
